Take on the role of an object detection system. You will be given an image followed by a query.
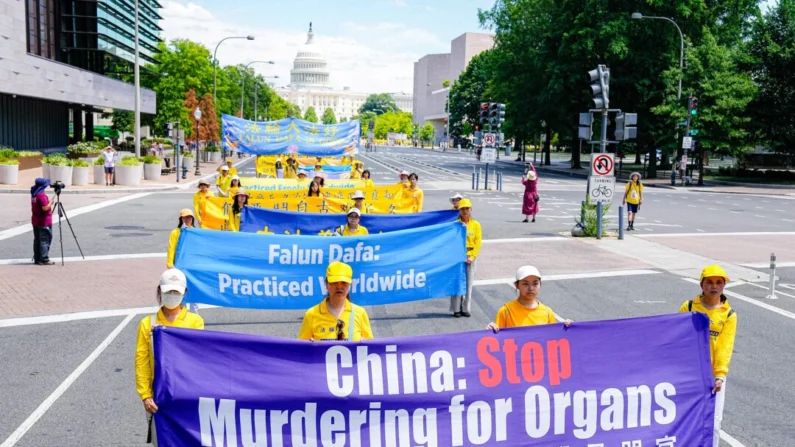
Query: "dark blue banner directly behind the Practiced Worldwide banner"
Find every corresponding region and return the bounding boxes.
[240,206,458,235]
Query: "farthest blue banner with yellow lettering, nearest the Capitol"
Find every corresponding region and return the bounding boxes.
[221,115,360,157]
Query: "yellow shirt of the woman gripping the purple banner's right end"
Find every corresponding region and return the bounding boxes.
[679,295,737,379]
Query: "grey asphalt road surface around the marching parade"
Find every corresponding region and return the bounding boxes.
[0,148,795,447]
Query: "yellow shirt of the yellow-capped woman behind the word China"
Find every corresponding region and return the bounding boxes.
[298,299,373,341]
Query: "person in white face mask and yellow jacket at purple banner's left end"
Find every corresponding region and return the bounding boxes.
[135,269,204,446]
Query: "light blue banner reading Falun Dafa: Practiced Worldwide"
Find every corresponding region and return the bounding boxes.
[175,222,466,309]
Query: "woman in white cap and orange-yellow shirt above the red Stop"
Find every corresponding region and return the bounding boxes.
[487,265,571,334]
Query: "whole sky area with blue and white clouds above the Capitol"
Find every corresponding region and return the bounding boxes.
[160,0,494,93]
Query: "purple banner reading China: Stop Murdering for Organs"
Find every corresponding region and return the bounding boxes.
[154,313,714,447]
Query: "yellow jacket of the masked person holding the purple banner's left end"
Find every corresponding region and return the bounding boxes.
[135,306,204,400]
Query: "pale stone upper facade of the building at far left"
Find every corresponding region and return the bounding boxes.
[0,0,157,114]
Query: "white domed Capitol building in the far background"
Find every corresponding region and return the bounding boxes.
[275,23,413,122]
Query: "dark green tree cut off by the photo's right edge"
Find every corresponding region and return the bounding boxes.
[748,0,795,157]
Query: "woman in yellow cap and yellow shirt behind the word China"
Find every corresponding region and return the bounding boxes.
[298,262,373,341]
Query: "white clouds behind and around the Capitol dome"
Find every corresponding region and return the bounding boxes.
[160,0,449,92]
